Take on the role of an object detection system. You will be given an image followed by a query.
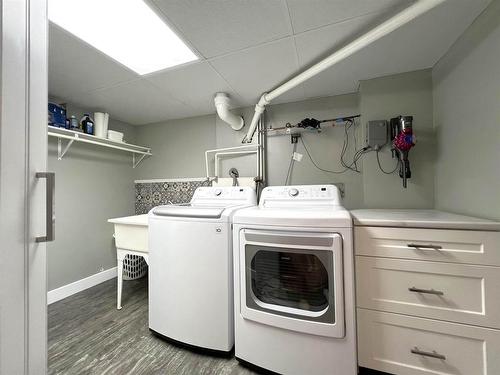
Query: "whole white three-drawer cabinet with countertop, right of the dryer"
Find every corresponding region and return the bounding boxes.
[352,210,500,375]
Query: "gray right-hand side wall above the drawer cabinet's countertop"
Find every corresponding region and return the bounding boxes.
[433,1,500,220]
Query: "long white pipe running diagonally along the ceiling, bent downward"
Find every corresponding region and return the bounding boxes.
[243,0,446,143]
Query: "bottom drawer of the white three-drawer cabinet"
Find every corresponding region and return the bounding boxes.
[358,309,500,375]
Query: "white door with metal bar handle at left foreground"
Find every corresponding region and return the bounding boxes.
[0,0,50,375]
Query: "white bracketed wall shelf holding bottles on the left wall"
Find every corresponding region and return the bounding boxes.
[48,126,153,168]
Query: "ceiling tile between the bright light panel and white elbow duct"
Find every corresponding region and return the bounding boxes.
[145,61,242,114]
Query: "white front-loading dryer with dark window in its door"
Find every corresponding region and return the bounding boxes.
[233,185,357,375]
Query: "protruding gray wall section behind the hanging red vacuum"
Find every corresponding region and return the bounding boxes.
[360,70,435,208]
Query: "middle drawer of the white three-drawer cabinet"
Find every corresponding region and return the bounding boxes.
[356,256,500,328]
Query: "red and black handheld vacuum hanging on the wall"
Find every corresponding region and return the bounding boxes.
[390,116,415,188]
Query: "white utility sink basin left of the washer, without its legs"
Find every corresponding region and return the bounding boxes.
[108,214,148,253]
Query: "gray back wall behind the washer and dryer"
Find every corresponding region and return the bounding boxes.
[136,70,435,212]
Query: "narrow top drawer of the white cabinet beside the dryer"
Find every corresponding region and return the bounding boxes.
[354,227,500,266]
